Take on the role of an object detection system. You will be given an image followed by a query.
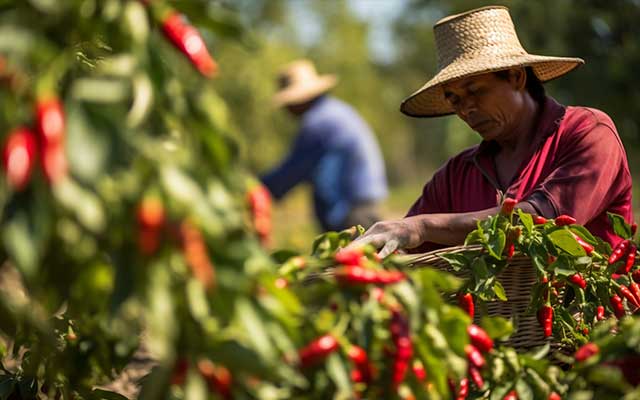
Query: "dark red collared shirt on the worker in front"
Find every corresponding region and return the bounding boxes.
[407,97,633,251]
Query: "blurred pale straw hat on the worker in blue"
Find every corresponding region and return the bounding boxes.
[273,60,338,106]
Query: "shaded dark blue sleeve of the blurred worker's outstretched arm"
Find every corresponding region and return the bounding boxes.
[260,127,326,199]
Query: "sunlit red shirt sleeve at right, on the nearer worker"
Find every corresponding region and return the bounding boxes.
[530,122,630,225]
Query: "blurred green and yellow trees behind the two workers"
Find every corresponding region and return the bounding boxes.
[213,0,640,249]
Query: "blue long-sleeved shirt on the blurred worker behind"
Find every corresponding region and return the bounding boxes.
[262,96,387,230]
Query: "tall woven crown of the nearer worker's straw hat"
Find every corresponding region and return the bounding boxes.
[434,6,527,70]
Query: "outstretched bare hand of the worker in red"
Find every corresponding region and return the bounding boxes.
[347,215,425,258]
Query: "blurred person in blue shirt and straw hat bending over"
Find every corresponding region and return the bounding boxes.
[261,60,387,231]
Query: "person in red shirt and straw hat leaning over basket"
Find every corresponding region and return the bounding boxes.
[350,6,633,257]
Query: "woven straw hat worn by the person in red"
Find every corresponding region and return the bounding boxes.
[400,6,584,117]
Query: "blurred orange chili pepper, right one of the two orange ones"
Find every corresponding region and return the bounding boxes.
[180,221,216,290]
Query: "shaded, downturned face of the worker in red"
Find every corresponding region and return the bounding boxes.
[443,70,527,141]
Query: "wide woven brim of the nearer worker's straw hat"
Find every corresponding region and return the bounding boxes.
[400,53,584,118]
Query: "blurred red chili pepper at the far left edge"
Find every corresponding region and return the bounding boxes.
[2,128,38,190]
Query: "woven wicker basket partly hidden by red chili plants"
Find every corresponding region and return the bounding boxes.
[407,246,557,350]
